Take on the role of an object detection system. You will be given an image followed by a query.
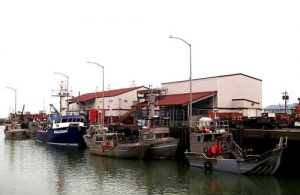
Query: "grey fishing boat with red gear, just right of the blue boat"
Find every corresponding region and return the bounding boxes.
[83,126,149,159]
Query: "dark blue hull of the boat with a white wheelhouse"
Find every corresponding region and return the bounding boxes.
[36,126,86,146]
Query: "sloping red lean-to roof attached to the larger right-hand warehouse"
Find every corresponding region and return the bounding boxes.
[158,91,215,106]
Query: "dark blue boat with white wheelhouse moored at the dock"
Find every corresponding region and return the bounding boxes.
[36,115,86,146]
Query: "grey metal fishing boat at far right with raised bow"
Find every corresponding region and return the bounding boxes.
[185,118,287,175]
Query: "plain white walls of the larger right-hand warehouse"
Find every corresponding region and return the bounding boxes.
[162,74,262,116]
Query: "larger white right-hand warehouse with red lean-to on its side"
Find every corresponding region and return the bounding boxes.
[162,73,262,117]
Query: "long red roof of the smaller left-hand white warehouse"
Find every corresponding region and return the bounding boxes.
[68,86,144,102]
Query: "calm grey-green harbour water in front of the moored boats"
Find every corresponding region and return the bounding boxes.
[0,127,300,195]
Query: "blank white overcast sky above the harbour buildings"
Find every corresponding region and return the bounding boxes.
[0,0,300,117]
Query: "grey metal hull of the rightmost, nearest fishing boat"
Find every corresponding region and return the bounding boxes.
[185,148,283,175]
